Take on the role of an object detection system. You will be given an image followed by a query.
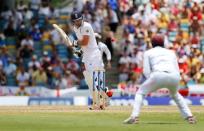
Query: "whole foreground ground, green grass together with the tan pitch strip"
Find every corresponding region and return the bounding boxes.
[0,106,204,131]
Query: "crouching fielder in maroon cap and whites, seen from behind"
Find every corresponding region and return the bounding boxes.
[124,35,196,124]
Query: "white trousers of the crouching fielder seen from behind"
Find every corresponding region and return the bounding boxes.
[131,72,192,118]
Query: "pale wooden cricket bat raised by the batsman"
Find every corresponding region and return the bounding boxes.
[53,24,73,46]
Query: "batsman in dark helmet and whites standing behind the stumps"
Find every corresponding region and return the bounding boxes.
[71,11,111,110]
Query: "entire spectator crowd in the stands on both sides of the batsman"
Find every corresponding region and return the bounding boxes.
[0,0,204,89]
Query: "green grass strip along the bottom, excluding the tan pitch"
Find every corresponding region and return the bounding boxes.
[0,107,204,131]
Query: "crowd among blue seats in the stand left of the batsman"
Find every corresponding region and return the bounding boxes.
[0,0,81,89]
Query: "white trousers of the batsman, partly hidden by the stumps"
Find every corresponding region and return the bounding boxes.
[83,58,104,97]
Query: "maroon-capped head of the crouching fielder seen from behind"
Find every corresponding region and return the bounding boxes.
[151,34,164,47]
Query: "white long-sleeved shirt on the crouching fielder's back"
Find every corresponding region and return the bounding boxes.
[143,47,179,78]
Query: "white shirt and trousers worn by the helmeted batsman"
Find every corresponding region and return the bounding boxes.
[74,22,104,94]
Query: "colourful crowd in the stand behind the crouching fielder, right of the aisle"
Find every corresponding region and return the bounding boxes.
[118,0,204,88]
